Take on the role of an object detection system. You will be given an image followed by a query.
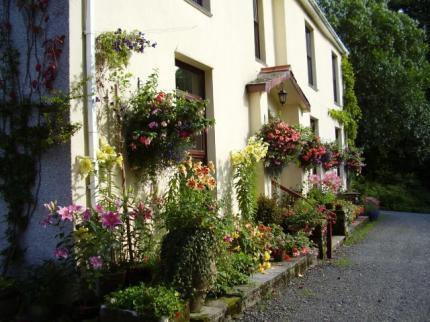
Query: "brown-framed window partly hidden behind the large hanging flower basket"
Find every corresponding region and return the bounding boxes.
[175,60,207,163]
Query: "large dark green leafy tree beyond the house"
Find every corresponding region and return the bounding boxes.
[320,0,430,177]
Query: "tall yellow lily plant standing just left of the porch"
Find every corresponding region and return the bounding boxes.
[231,136,268,220]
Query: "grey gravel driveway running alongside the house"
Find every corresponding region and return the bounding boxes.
[239,212,430,322]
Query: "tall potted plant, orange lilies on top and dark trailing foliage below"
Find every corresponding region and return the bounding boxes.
[160,158,220,312]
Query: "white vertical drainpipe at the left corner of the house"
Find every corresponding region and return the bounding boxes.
[85,0,99,206]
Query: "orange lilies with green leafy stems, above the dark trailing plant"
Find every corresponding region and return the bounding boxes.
[163,157,218,230]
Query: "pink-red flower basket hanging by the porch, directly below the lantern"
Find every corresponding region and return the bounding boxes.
[257,121,300,175]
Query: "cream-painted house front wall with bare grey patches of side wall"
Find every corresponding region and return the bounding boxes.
[0,0,347,263]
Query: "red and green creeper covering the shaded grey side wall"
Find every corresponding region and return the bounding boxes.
[0,0,79,274]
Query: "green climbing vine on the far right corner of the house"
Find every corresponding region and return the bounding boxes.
[329,56,361,146]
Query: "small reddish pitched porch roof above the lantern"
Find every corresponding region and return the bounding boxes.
[246,65,311,111]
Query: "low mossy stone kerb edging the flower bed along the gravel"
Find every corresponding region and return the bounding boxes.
[190,217,368,322]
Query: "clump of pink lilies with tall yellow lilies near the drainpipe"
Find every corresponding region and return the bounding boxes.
[42,143,163,287]
